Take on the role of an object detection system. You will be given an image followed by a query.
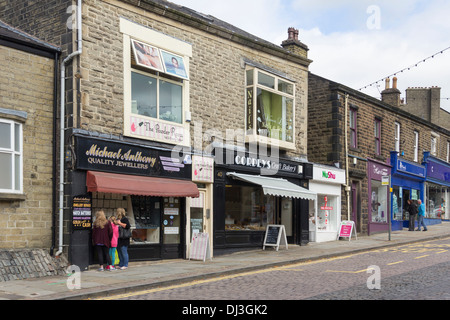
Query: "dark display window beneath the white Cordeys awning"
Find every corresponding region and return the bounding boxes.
[225,185,276,231]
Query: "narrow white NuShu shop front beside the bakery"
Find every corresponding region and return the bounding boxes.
[309,164,346,242]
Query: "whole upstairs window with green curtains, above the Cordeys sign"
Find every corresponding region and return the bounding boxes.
[246,68,295,146]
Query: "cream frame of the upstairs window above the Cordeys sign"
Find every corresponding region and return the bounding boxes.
[244,66,296,150]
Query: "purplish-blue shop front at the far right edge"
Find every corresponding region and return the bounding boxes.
[424,152,450,224]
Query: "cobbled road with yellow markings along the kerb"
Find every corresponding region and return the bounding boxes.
[101,238,450,303]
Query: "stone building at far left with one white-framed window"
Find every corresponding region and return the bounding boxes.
[0,21,59,251]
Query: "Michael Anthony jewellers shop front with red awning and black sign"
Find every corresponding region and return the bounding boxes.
[70,135,200,265]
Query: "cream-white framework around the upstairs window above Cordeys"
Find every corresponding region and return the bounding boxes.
[245,66,296,150]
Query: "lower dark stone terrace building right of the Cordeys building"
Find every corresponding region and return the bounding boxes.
[308,73,450,234]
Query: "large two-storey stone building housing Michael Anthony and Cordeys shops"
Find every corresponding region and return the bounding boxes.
[0,0,312,265]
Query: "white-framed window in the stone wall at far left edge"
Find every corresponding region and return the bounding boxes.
[0,119,23,193]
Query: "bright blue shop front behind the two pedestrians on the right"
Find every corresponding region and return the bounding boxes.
[391,151,426,231]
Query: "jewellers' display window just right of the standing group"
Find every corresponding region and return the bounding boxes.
[128,196,161,245]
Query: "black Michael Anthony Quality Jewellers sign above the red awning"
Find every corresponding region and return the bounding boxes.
[76,137,192,179]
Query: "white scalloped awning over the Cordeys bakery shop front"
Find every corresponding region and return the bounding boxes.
[227,172,317,200]
